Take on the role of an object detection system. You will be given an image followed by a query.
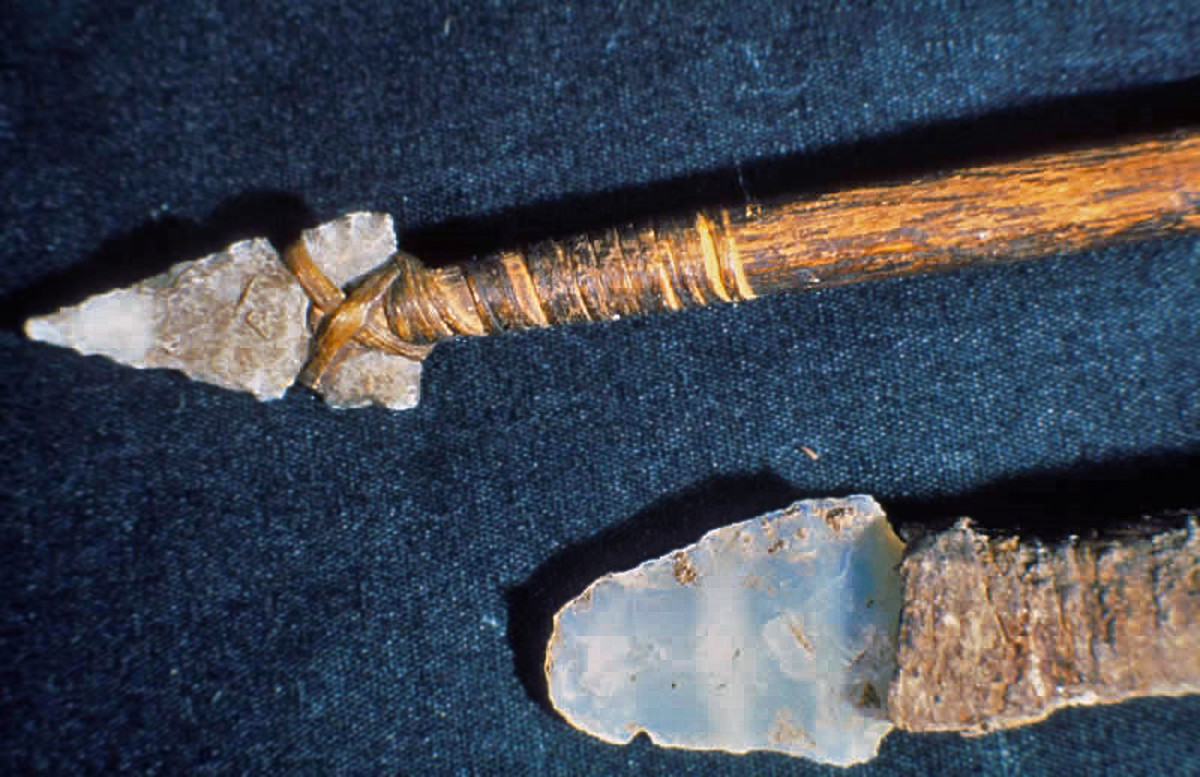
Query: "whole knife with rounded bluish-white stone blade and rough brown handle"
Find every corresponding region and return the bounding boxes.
[546,496,1200,766]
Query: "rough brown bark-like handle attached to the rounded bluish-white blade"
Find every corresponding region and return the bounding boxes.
[887,520,1200,734]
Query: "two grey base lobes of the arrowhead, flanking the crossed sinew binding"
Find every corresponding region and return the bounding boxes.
[298,213,421,410]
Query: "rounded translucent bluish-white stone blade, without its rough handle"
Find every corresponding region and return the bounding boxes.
[546,496,904,766]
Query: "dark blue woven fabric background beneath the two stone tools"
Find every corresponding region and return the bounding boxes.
[0,0,1200,777]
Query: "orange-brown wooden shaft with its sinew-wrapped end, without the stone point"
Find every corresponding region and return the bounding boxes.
[385,132,1200,344]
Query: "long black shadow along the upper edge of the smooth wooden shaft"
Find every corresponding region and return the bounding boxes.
[403,78,1200,266]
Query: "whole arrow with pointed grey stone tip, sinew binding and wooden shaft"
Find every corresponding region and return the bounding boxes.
[18,132,1200,409]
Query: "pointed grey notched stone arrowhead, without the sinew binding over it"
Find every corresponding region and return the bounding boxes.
[25,213,421,410]
